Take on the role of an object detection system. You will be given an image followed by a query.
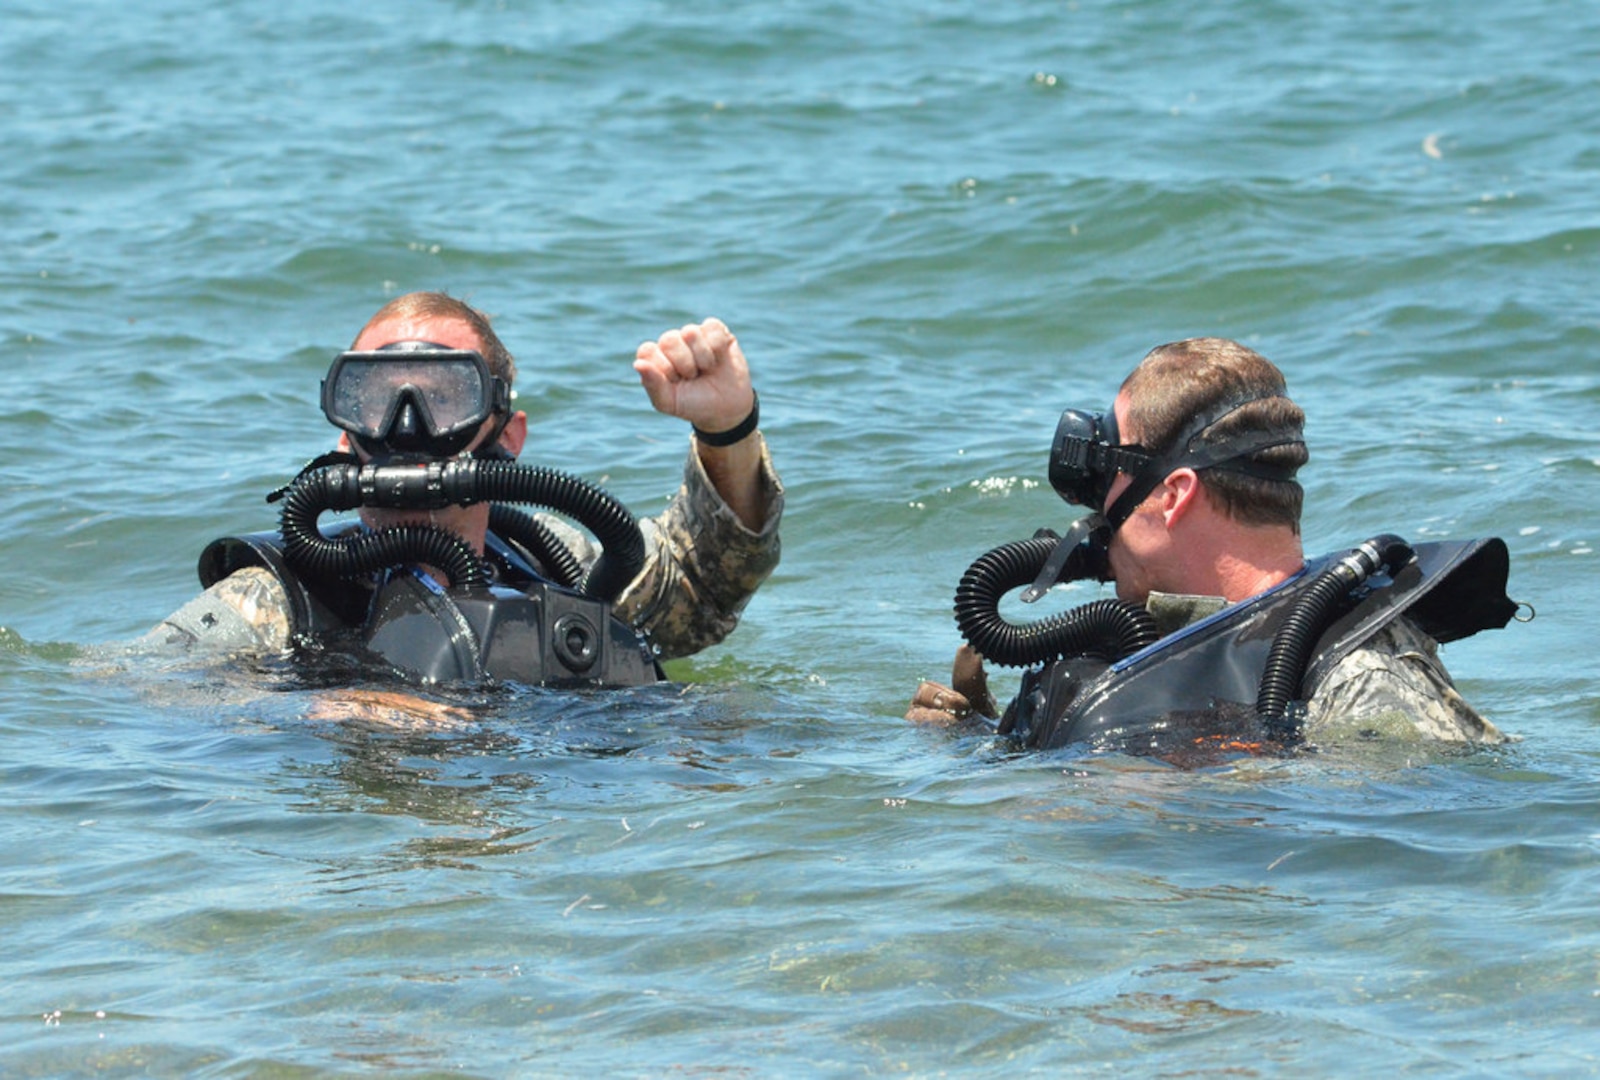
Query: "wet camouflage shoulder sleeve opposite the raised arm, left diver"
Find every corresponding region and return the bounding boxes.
[134,566,291,653]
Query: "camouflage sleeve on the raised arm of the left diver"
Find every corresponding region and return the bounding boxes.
[604,435,784,659]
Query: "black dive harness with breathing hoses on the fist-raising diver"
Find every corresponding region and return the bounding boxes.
[198,453,662,686]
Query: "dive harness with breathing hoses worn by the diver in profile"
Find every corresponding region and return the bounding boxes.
[955,515,1518,752]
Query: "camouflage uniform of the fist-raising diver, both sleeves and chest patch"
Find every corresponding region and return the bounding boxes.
[139,435,784,659]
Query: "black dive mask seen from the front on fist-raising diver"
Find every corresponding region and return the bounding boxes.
[322,341,510,461]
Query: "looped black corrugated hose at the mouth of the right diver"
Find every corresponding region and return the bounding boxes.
[955,536,1158,667]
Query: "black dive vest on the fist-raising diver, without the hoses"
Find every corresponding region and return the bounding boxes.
[200,521,664,686]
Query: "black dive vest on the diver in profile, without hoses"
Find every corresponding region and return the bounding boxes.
[1000,539,1517,754]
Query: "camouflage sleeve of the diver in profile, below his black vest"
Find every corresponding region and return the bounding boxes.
[1306,618,1506,742]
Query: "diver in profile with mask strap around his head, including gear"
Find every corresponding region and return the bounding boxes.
[909,338,1517,757]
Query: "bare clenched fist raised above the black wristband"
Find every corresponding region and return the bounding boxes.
[634,318,755,432]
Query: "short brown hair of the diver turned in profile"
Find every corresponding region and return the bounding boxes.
[1122,338,1310,533]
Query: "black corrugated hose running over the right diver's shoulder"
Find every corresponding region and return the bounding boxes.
[1256,533,1413,726]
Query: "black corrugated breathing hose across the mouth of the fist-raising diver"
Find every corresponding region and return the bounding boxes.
[280,459,645,600]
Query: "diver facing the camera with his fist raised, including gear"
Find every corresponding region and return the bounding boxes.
[149,293,782,686]
